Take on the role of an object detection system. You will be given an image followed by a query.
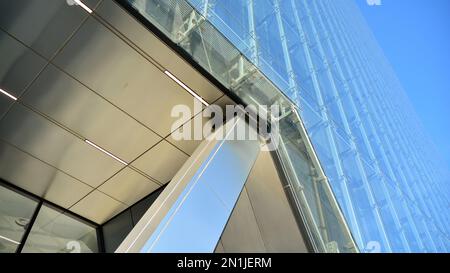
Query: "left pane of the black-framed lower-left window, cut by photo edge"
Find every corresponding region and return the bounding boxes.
[0,186,37,253]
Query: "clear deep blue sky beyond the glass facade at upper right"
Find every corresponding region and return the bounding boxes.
[356,0,450,169]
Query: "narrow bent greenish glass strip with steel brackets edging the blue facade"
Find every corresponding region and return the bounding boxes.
[118,0,358,252]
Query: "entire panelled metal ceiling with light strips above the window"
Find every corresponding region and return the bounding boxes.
[0,0,222,223]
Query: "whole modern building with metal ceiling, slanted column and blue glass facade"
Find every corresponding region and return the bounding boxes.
[0,0,450,253]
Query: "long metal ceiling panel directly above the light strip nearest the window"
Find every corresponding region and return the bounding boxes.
[24,63,161,162]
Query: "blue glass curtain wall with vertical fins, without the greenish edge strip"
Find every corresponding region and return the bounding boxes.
[182,0,450,252]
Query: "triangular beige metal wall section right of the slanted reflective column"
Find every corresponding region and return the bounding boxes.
[216,152,307,253]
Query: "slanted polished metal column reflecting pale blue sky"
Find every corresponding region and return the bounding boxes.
[117,118,260,252]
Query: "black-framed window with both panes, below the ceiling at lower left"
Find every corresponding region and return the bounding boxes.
[0,181,100,253]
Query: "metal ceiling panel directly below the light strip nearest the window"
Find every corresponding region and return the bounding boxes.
[0,104,123,187]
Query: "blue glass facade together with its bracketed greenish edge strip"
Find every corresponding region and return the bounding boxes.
[123,0,450,252]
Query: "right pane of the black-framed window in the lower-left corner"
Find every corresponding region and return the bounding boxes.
[22,205,98,253]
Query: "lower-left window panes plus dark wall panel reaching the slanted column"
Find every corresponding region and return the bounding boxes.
[0,178,165,253]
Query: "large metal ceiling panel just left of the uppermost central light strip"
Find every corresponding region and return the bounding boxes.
[55,18,201,136]
